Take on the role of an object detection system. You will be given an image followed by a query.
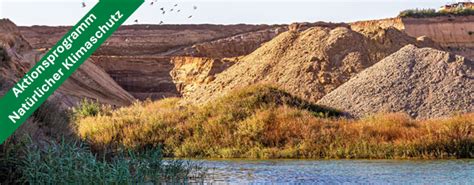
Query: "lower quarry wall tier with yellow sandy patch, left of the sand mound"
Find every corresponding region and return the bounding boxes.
[92,56,233,100]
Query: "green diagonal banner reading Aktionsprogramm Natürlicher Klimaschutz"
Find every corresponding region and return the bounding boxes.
[0,0,144,143]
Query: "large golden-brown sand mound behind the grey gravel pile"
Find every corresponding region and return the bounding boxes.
[184,26,430,103]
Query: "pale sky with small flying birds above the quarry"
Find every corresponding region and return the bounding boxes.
[0,0,454,26]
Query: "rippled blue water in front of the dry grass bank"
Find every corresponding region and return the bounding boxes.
[193,160,474,185]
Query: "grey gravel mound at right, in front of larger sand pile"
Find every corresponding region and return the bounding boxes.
[318,45,474,119]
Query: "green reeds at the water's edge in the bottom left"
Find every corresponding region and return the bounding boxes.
[17,141,205,184]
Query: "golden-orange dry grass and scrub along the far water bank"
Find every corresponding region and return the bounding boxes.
[77,86,474,159]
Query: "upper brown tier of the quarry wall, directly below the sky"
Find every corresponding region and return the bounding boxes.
[20,24,275,56]
